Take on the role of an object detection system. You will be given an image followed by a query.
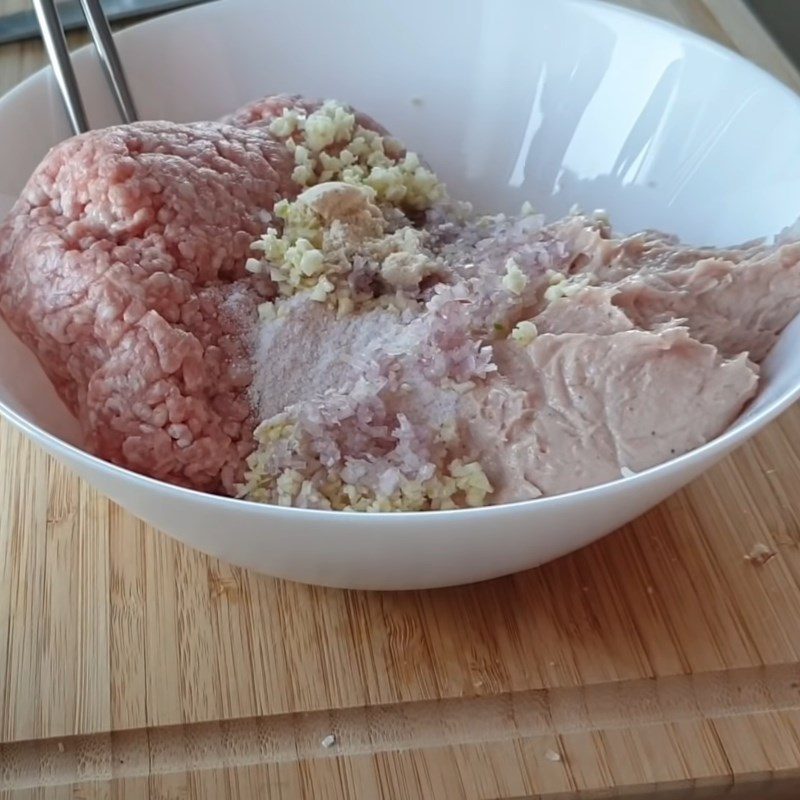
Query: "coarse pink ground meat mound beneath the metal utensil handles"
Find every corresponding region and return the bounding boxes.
[0,111,293,491]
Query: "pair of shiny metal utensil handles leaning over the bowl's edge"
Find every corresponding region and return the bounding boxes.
[33,0,138,133]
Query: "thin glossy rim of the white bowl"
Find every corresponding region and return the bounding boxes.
[0,0,800,525]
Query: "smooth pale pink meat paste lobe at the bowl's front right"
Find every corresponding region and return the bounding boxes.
[472,306,757,503]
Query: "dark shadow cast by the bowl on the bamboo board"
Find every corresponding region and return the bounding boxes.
[356,466,761,695]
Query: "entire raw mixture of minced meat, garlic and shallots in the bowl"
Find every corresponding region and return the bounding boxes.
[0,96,800,511]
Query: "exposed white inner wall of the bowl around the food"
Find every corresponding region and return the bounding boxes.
[0,0,800,468]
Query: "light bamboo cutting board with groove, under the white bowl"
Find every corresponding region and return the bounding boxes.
[0,0,800,800]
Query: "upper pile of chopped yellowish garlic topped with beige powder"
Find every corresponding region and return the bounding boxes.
[245,100,454,319]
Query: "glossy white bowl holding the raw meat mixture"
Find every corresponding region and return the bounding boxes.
[0,0,800,589]
